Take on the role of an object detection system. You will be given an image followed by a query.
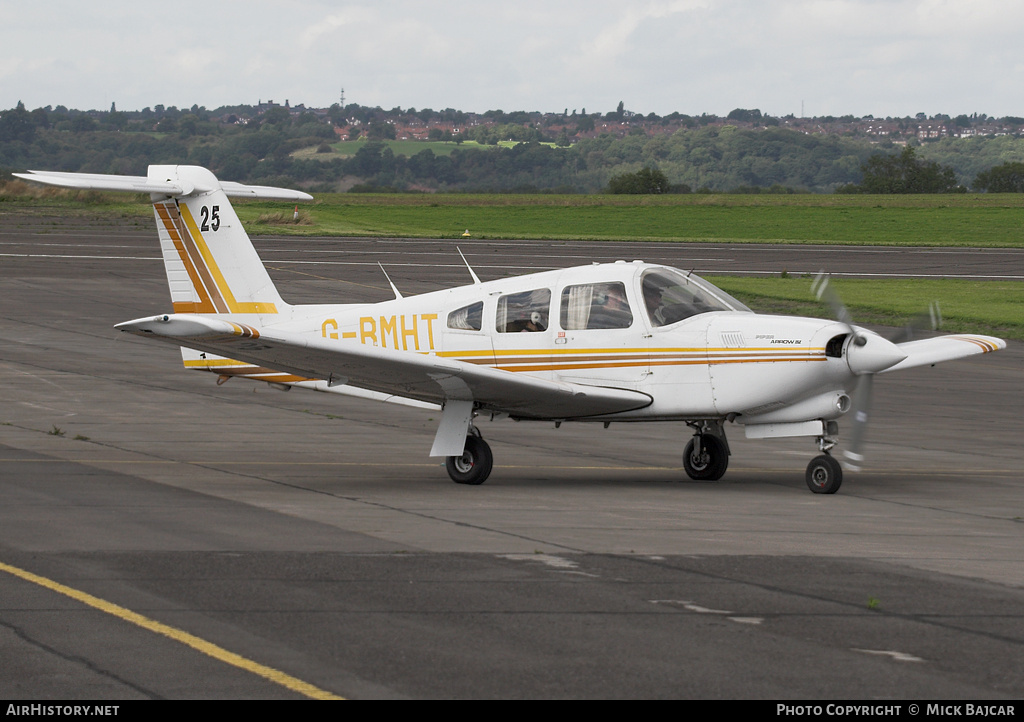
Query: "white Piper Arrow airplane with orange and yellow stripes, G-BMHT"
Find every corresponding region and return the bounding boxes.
[15,166,1006,494]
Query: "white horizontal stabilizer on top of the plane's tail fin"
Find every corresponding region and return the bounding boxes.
[14,166,313,201]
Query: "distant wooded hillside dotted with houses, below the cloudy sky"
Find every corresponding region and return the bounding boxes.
[0,99,1024,193]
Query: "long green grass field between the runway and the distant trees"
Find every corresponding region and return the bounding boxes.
[239,194,1024,248]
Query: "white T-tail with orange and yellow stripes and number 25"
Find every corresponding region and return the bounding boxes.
[15,166,312,321]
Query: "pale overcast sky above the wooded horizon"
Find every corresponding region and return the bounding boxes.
[0,0,1024,117]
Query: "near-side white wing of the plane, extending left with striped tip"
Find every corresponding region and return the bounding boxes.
[116,313,651,419]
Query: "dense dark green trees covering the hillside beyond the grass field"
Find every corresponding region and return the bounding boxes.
[6,103,1024,193]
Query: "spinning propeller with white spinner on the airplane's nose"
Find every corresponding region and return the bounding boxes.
[811,271,942,471]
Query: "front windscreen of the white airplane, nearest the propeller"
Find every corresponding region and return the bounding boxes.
[640,268,751,327]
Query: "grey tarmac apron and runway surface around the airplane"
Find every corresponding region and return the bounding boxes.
[0,211,1024,700]
